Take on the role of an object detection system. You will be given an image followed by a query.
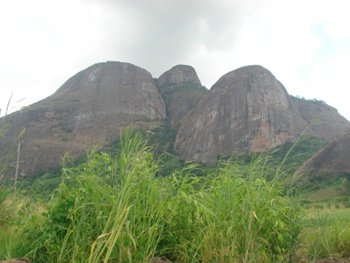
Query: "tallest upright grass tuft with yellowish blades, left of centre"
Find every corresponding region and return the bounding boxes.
[89,133,163,262]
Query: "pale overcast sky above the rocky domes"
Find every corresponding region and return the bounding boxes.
[0,0,350,119]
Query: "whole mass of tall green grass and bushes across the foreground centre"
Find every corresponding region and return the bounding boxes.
[0,132,300,263]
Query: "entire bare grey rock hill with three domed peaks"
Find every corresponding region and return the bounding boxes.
[0,62,350,176]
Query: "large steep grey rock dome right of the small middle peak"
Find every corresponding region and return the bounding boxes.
[175,66,307,163]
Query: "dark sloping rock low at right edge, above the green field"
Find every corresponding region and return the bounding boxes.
[300,132,350,177]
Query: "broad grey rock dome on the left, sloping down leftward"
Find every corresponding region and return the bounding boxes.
[0,62,166,174]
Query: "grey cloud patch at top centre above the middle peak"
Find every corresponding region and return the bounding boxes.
[86,0,247,75]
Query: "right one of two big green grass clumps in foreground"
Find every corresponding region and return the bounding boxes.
[157,160,299,262]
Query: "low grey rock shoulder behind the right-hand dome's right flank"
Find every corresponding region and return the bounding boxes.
[292,97,350,141]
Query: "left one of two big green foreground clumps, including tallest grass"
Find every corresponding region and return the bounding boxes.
[27,133,163,262]
